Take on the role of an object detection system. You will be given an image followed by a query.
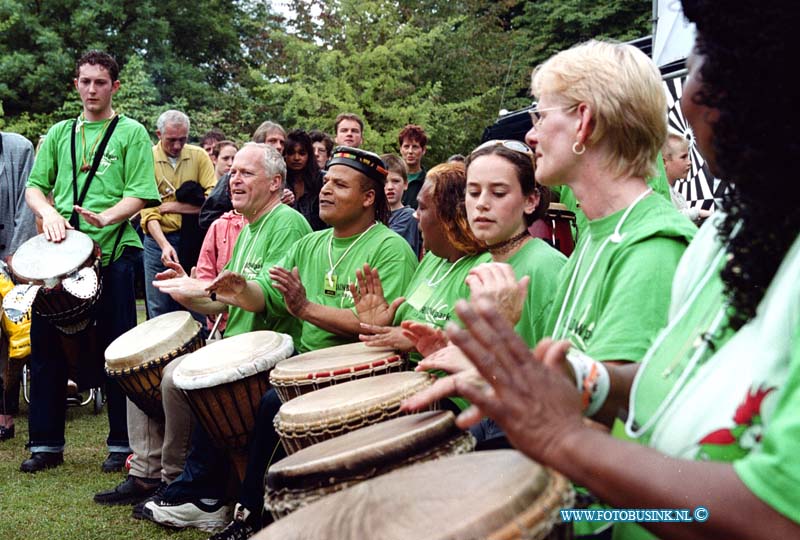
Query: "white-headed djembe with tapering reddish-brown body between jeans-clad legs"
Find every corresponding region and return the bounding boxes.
[172,330,294,479]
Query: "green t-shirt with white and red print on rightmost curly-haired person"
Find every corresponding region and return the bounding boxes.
[614,221,800,540]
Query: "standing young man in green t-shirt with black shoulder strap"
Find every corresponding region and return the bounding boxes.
[20,51,159,472]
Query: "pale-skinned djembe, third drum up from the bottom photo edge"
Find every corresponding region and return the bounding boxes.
[274,371,435,454]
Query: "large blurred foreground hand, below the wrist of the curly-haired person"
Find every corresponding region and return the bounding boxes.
[447,300,585,465]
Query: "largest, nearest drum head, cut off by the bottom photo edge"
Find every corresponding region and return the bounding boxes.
[255,450,571,540]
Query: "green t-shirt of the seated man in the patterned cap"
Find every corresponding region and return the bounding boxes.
[256,223,417,353]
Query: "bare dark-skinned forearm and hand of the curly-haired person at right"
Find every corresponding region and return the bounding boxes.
[428,302,800,539]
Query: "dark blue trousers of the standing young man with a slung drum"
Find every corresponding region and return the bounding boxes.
[28,247,141,453]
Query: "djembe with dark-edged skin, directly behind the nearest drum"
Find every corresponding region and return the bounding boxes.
[264,411,475,519]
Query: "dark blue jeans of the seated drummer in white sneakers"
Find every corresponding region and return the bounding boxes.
[164,389,286,514]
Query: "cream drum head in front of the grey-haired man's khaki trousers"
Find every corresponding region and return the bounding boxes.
[105,311,200,370]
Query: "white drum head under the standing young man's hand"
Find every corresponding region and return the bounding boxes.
[11,229,94,286]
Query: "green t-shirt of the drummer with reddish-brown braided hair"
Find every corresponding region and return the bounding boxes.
[393,252,492,328]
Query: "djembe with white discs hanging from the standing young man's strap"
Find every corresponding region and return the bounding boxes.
[3,229,103,334]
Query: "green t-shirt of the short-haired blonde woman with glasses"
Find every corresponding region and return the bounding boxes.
[546,194,697,361]
